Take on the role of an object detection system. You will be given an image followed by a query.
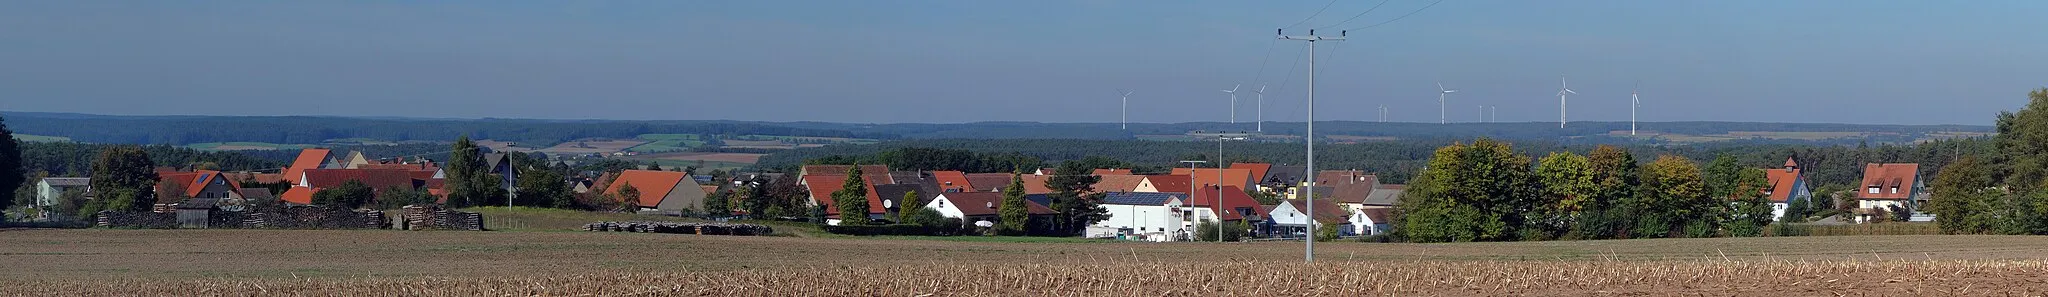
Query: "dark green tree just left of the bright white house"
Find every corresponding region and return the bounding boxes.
[1044,158,1120,236]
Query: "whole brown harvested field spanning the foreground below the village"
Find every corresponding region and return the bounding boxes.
[0,229,2048,295]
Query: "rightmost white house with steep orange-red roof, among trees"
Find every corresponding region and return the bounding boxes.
[1855,164,1929,221]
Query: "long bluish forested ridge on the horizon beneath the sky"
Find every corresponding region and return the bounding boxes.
[0,113,1993,147]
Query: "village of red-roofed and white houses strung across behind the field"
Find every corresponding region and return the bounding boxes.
[35,147,1933,242]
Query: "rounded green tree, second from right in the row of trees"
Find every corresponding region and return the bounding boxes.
[1634,156,1726,238]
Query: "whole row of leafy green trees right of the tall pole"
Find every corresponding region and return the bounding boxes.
[1395,139,1774,242]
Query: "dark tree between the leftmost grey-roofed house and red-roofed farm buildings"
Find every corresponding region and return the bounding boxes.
[80,145,156,217]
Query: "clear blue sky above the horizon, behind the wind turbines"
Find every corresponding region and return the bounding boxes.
[0,0,2048,125]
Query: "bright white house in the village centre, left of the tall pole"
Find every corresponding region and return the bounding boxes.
[1081,193,1188,242]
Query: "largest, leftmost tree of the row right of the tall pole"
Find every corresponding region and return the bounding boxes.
[1395,139,1538,242]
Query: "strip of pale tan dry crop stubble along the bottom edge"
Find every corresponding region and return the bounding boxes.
[12,260,2048,297]
